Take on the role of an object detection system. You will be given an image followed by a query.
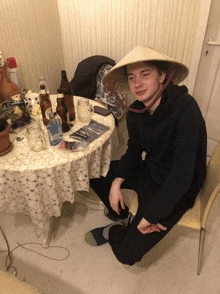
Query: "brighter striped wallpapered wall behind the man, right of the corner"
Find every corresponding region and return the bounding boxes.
[58,0,211,92]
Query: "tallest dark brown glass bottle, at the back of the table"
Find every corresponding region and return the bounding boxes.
[60,70,75,121]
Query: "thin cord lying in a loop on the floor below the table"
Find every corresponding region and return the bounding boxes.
[0,226,70,276]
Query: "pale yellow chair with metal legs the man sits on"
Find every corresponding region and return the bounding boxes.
[130,142,220,275]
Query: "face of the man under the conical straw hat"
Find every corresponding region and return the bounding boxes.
[127,62,166,106]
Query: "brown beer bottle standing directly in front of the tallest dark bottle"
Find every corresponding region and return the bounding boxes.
[56,89,70,133]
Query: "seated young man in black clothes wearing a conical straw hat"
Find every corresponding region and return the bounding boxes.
[86,46,207,265]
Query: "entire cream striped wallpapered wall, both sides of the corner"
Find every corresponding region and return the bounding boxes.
[0,0,211,93]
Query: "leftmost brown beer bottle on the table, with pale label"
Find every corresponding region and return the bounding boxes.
[40,85,52,126]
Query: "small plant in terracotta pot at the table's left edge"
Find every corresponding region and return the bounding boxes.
[0,101,20,156]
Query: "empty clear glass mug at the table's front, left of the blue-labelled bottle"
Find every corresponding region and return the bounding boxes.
[26,120,47,152]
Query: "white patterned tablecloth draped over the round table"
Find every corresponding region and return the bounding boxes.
[0,95,118,236]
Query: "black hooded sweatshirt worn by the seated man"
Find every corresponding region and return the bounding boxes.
[116,83,207,224]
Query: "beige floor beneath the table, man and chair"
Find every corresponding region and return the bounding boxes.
[0,189,220,294]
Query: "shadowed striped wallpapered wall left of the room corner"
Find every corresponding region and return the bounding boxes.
[0,0,64,92]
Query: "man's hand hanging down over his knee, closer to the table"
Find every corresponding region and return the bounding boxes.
[109,178,125,215]
